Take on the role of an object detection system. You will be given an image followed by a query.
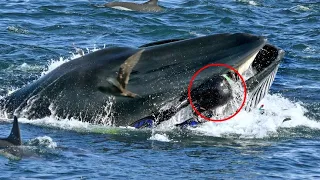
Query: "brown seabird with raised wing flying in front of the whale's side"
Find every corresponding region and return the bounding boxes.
[113,50,144,98]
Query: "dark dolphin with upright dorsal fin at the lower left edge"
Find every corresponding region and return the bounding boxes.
[0,116,22,149]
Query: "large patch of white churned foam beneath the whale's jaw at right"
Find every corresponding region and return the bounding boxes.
[191,95,320,138]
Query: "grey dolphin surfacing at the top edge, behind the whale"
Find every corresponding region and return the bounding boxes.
[99,0,164,12]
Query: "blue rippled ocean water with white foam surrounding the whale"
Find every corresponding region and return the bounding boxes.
[0,0,320,179]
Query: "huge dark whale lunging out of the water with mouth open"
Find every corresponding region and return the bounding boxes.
[0,33,284,126]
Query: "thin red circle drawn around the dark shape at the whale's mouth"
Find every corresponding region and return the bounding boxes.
[188,63,247,122]
